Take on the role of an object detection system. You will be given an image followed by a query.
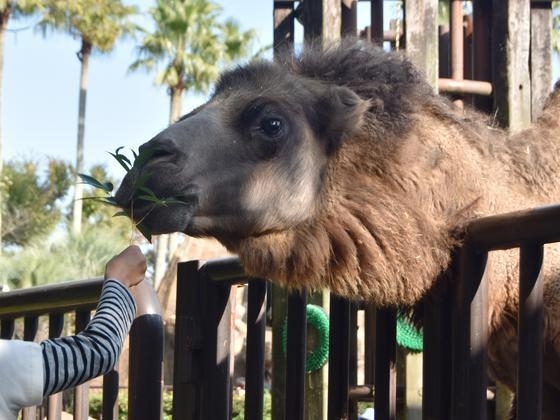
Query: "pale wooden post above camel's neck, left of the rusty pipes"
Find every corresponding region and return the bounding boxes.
[404,0,439,90]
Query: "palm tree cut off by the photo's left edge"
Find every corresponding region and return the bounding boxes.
[0,0,42,254]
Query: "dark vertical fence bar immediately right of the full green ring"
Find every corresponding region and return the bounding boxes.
[327,294,350,420]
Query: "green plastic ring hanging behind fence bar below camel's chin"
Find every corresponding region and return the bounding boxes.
[282,305,329,373]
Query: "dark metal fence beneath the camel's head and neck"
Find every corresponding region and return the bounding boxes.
[173,206,560,420]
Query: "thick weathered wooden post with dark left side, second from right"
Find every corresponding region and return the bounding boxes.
[492,0,531,132]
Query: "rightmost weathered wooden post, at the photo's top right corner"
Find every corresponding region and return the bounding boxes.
[531,1,552,121]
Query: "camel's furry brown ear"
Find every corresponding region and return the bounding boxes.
[317,86,369,153]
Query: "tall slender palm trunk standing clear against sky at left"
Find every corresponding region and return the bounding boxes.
[72,39,92,235]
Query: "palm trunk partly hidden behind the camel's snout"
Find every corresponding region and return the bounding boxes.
[154,85,184,288]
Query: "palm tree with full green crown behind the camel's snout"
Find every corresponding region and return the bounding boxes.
[130,0,255,282]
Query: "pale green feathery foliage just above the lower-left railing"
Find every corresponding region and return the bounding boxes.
[0,226,128,289]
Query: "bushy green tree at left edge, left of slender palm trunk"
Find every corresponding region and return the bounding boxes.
[0,159,71,246]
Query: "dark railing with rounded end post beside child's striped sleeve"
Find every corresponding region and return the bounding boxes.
[0,278,163,420]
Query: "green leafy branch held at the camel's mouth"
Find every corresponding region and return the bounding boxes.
[78,146,185,242]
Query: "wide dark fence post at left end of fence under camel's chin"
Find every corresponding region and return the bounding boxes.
[173,261,206,420]
